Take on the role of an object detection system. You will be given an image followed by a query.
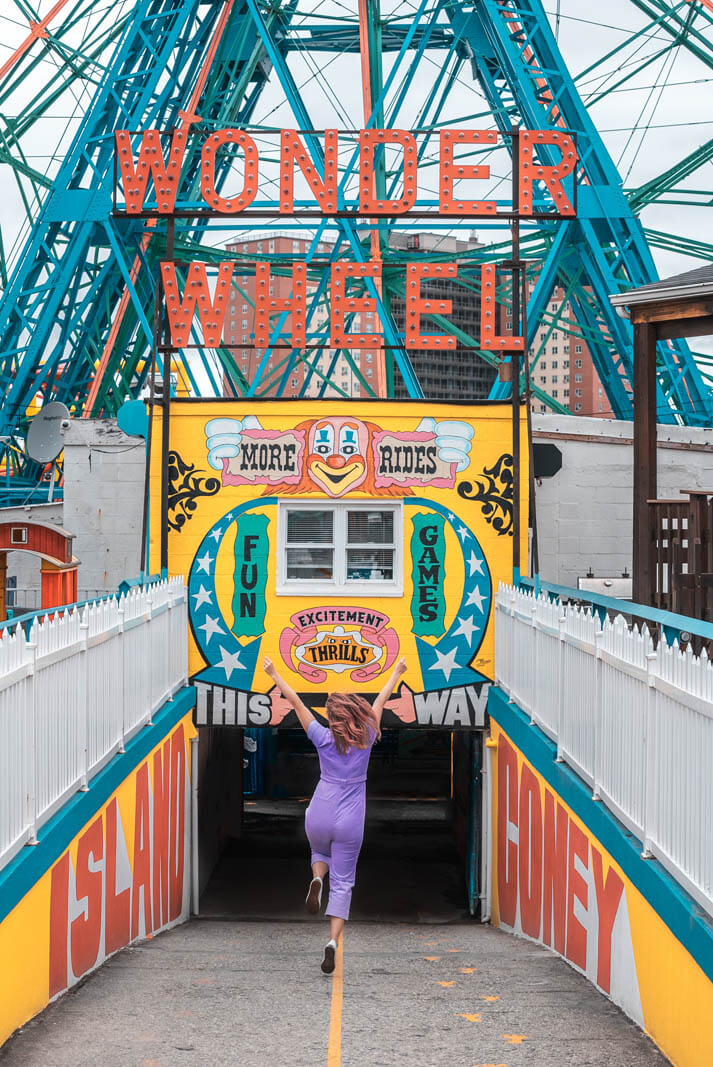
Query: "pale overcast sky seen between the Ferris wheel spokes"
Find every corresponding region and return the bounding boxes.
[0,0,713,348]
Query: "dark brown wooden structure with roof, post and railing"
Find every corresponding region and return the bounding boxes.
[609,264,713,620]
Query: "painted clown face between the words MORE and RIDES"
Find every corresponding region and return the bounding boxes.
[307,417,368,496]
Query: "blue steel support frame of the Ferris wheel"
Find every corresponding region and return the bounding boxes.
[0,0,713,499]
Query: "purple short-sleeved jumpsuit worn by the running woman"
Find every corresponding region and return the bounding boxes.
[304,721,376,919]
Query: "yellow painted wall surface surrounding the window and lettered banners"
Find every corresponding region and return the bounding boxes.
[150,400,527,724]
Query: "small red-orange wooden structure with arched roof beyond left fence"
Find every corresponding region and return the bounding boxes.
[0,522,79,622]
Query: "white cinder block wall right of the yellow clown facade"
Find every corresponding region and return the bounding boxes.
[533,415,713,586]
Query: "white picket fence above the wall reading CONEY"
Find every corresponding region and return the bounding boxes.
[495,585,713,914]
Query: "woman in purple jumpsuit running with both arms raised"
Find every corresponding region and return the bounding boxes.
[263,658,407,974]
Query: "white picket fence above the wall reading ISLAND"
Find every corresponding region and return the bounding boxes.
[0,578,188,866]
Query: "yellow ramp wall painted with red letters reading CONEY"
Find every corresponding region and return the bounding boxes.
[491,719,713,1067]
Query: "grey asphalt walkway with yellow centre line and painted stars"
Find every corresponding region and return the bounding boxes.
[0,920,667,1067]
